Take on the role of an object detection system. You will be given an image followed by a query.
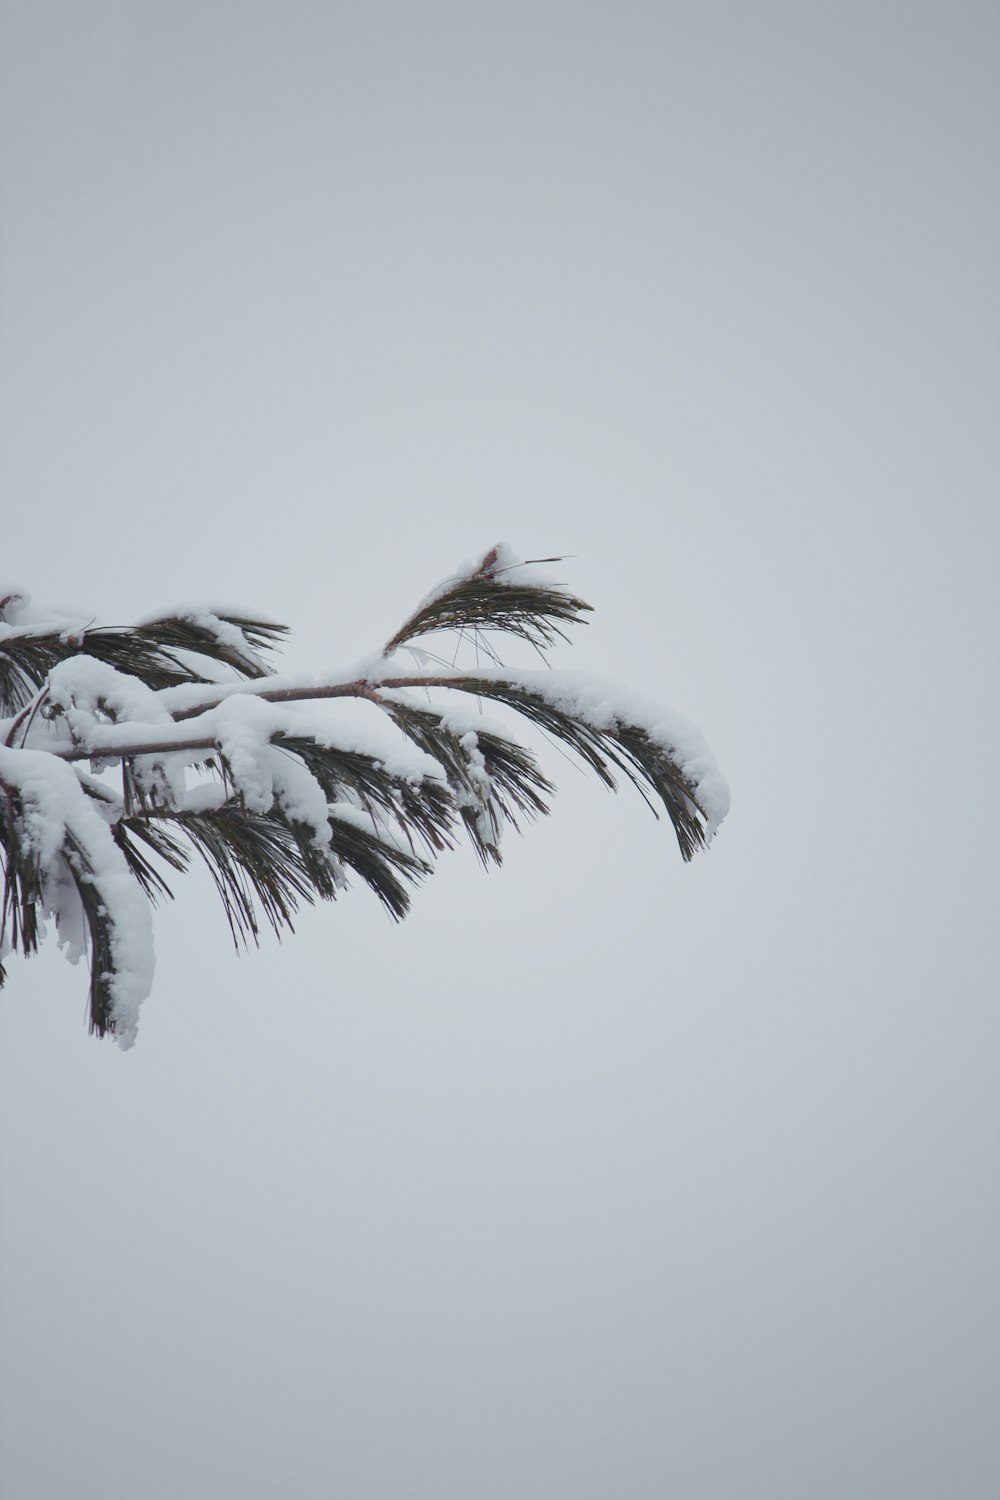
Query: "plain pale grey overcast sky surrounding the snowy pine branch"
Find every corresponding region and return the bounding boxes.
[0,0,1000,1500]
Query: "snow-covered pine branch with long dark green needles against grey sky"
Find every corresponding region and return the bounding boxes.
[0,545,729,1047]
